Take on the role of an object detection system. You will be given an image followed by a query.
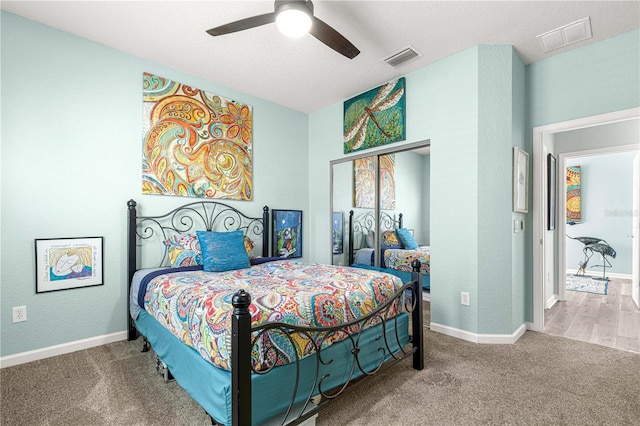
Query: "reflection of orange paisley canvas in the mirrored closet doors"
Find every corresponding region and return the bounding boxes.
[353,154,396,210]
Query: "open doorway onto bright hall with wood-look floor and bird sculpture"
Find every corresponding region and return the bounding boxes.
[544,146,640,353]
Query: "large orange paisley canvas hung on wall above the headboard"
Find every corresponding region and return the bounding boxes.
[142,73,253,200]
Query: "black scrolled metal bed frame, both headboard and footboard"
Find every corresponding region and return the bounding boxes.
[127,200,424,426]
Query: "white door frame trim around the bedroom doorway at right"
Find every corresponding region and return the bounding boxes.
[531,107,640,332]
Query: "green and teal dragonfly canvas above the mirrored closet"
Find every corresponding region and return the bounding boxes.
[344,77,405,154]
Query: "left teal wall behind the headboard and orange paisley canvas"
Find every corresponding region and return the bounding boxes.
[0,12,309,356]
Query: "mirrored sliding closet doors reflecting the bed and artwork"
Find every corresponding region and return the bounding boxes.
[330,141,430,267]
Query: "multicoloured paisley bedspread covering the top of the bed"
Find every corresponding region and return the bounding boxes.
[144,260,402,369]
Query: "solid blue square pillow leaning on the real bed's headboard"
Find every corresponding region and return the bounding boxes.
[196,230,251,272]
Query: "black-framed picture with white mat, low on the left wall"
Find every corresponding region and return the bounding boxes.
[35,237,104,293]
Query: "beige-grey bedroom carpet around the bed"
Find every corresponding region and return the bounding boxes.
[0,304,640,426]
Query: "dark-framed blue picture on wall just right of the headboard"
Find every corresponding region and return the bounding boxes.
[272,210,302,257]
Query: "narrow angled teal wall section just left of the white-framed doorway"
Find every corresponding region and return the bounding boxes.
[477,46,525,334]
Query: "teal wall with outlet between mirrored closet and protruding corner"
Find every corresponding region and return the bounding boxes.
[422,47,478,332]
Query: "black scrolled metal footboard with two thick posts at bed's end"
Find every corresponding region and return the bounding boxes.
[231,261,424,426]
